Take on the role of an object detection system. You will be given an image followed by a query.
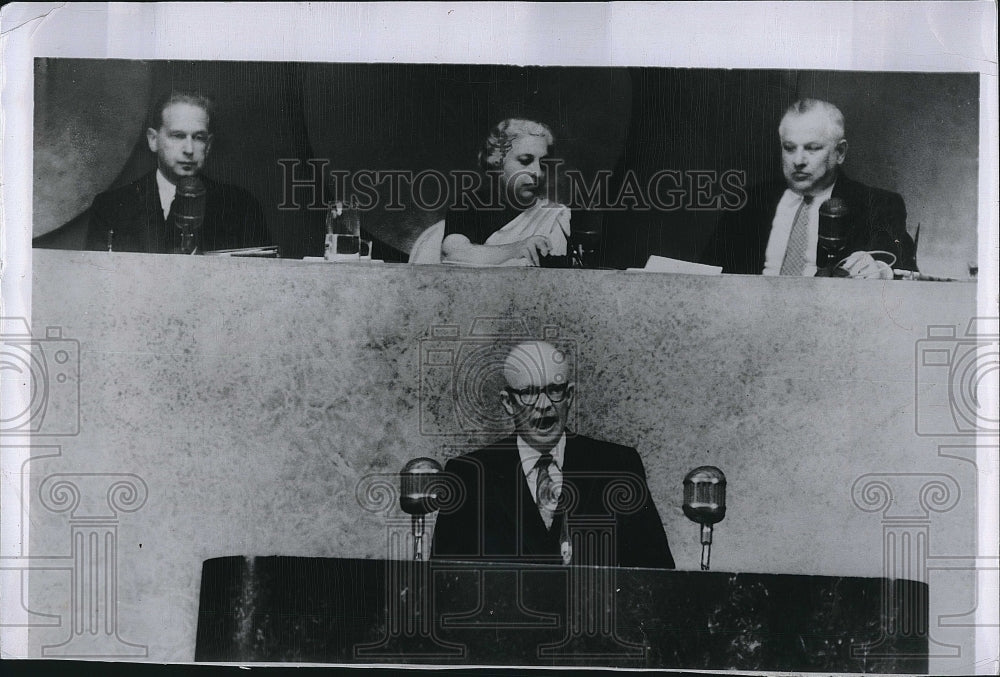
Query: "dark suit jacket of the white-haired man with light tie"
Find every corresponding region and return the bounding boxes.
[703,173,917,275]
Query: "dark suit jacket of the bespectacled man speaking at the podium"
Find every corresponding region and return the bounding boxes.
[431,435,674,569]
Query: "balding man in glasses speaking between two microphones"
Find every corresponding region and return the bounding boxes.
[432,341,674,569]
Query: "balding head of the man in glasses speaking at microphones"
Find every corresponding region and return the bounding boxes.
[500,341,574,452]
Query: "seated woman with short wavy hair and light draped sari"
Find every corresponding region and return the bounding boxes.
[441,118,570,266]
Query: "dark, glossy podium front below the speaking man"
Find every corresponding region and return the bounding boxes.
[195,557,928,673]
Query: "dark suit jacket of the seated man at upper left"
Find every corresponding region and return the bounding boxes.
[86,171,270,254]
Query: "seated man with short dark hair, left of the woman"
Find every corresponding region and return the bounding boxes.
[86,92,270,254]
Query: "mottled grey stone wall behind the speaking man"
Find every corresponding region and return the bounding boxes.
[28,250,976,666]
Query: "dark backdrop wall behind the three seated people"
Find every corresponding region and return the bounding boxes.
[34,59,979,278]
